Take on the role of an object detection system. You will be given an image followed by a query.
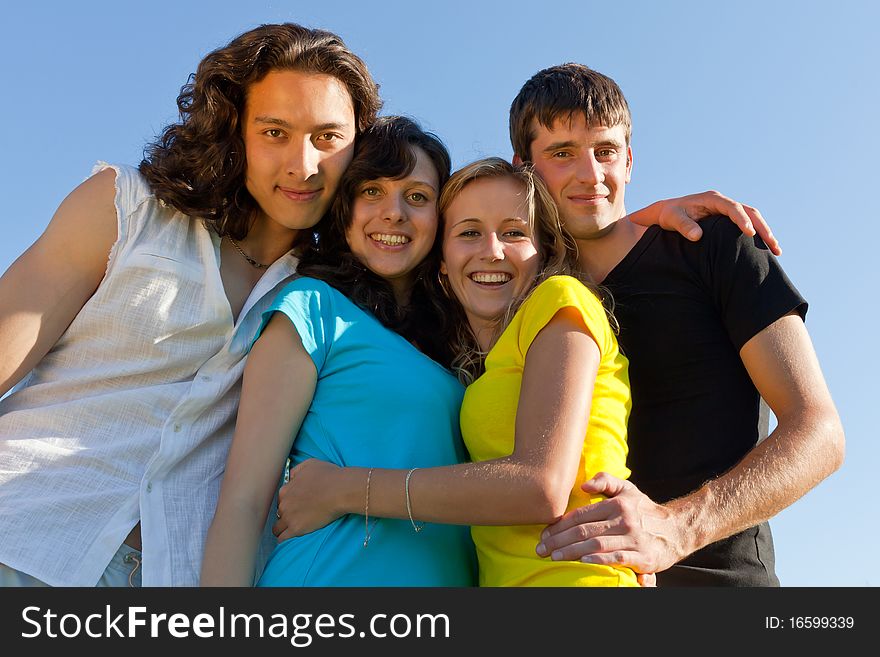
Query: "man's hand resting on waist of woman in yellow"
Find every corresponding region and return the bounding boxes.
[536,472,685,586]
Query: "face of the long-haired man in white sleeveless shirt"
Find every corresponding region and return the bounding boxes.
[242,70,355,235]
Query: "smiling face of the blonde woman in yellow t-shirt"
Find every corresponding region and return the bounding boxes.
[440,176,540,348]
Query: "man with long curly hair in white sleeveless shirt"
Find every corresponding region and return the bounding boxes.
[0,24,380,586]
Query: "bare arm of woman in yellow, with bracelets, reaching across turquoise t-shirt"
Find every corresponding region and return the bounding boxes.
[275,308,599,539]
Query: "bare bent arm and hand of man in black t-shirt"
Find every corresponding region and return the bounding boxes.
[538,315,844,572]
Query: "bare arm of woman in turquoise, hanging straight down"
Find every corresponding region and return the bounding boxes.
[201,313,317,586]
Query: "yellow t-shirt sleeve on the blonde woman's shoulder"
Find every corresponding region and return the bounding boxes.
[518,276,612,355]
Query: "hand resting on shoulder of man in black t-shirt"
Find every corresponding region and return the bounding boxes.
[628,190,782,256]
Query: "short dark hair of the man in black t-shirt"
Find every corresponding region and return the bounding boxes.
[510,62,632,162]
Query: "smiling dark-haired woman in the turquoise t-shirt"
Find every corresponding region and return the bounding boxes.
[201,117,476,586]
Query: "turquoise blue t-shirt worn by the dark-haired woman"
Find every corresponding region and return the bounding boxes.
[251,277,476,586]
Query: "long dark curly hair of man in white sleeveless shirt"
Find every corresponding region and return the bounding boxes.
[140,23,381,239]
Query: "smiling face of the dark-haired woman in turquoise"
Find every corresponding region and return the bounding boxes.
[345,147,440,302]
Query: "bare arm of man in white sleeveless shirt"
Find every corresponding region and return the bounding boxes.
[0,169,117,395]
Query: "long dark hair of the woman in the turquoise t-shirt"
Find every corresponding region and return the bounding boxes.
[297,116,451,367]
